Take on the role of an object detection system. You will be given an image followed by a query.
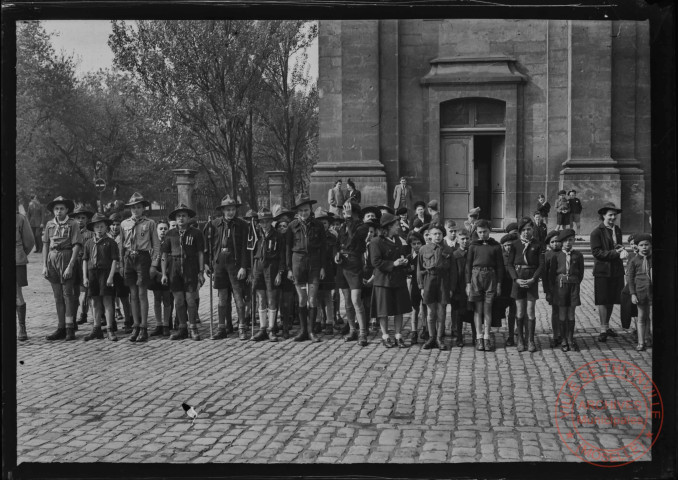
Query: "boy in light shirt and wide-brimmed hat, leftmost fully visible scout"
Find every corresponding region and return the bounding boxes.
[42,197,82,340]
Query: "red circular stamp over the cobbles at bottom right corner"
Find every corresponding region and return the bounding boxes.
[555,359,664,467]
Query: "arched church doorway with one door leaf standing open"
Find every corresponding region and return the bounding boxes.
[440,98,506,228]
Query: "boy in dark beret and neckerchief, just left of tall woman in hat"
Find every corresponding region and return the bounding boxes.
[549,229,584,352]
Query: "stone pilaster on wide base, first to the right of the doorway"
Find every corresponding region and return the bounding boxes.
[560,21,622,234]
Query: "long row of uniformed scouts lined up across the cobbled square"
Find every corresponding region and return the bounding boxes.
[17,193,652,352]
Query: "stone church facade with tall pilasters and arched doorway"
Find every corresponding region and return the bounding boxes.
[310,19,651,232]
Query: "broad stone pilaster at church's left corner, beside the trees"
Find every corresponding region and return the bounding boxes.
[309,20,387,208]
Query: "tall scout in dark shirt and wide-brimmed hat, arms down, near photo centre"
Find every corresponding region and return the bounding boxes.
[285,194,327,342]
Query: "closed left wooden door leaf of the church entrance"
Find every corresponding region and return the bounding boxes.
[440,135,473,223]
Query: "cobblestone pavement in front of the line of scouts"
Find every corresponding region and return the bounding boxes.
[17,254,651,463]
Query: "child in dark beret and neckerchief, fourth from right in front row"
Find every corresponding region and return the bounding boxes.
[506,218,544,352]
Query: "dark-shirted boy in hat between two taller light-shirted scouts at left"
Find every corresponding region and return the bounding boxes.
[82,213,120,342]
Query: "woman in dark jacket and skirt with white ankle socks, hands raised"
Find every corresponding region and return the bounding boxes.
[370,212,412,348]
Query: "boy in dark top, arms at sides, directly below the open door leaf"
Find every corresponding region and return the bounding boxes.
[465,220,504,351]
